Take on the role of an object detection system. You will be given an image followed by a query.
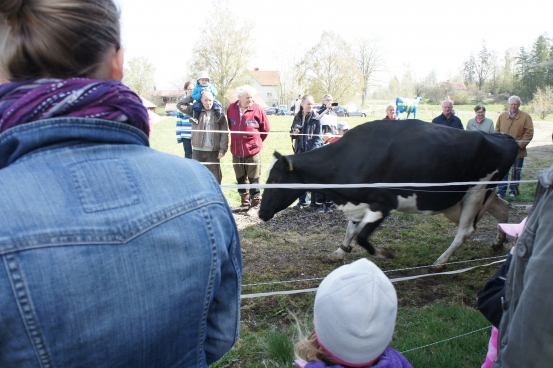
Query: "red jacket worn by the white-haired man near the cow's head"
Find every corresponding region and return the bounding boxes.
[227,101,271,157]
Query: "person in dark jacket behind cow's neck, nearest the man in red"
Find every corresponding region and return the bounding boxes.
[290,95,324,209]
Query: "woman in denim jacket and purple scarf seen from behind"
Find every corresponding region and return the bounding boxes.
[0,0,242,368]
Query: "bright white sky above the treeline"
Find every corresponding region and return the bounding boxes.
[116,0,553,89]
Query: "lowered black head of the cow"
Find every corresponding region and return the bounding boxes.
[259,151,305,221]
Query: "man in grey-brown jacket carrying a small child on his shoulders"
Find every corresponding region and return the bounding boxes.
[177,90,228,184]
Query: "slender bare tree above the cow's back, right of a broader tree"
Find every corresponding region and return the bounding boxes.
[353,37,384,106]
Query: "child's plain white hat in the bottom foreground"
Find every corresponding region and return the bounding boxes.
[314,258,397,366]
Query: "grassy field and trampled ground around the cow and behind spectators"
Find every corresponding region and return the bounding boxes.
[150,105,553,368]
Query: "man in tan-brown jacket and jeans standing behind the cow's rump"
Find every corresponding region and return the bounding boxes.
[495,96,534,199]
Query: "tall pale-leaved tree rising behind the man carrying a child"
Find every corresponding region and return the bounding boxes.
[189,3,253,107]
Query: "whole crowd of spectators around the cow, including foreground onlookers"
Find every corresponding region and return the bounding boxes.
[0,0,553,368]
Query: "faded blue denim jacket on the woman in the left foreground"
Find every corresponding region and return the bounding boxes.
[0,118,242,368]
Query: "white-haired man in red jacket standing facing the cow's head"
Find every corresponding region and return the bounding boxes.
[227,85,271,214]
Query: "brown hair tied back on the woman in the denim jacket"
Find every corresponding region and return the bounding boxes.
[0,0,121,81]
